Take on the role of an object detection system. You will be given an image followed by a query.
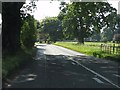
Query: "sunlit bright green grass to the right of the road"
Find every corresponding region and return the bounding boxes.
[54,42,120,61]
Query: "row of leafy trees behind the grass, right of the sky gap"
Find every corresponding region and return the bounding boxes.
[39,1,120,44]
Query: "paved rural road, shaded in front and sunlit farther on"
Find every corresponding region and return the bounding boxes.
[8,44,120,88]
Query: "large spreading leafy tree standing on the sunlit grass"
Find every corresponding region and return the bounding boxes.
[58,2,116,44]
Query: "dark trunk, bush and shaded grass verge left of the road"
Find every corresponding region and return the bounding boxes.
[2,2,37,83]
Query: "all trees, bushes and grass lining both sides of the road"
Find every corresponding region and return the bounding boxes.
[2,0,120,86]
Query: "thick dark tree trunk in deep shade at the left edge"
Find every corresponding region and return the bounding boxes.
[2,2,24,53]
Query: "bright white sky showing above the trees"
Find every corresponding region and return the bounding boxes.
[34,0,119,20]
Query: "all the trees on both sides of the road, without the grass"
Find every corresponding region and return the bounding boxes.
[2,0,120,50]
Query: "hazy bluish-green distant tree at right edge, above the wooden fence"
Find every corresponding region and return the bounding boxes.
[101,14,120,41]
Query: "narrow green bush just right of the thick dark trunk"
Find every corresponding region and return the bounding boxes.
[21,15,36,48]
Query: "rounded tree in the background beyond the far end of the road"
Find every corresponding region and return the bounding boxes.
[40,17,63,42]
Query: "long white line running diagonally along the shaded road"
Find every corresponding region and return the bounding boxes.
[72,60,120,88]
